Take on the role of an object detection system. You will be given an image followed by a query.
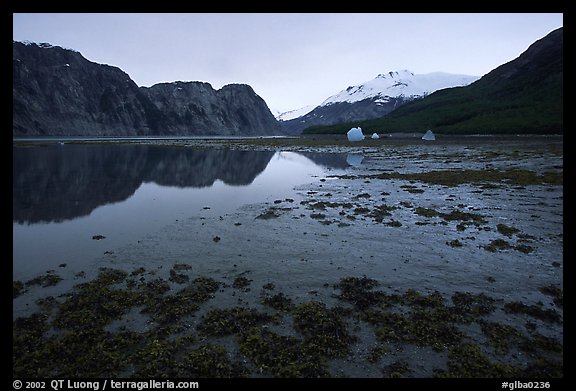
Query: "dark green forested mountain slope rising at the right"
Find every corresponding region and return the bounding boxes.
[304,28,564,134]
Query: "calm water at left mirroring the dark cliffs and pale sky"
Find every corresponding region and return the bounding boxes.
[13,144,352,281]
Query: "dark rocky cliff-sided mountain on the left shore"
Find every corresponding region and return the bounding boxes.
[12,41,280,136]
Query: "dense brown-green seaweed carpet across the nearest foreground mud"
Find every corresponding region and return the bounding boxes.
[13,265,563,378]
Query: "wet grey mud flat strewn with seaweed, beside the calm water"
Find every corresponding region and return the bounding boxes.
[13,137,563,378]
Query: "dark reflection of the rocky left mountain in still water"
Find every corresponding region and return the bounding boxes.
[12,144,274,223]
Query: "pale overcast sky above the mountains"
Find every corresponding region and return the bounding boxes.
[13,13,563,111]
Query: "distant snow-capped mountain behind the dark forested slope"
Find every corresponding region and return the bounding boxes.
[277,70,479,134]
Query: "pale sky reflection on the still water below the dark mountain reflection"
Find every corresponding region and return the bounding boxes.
[13,152,325,279]
